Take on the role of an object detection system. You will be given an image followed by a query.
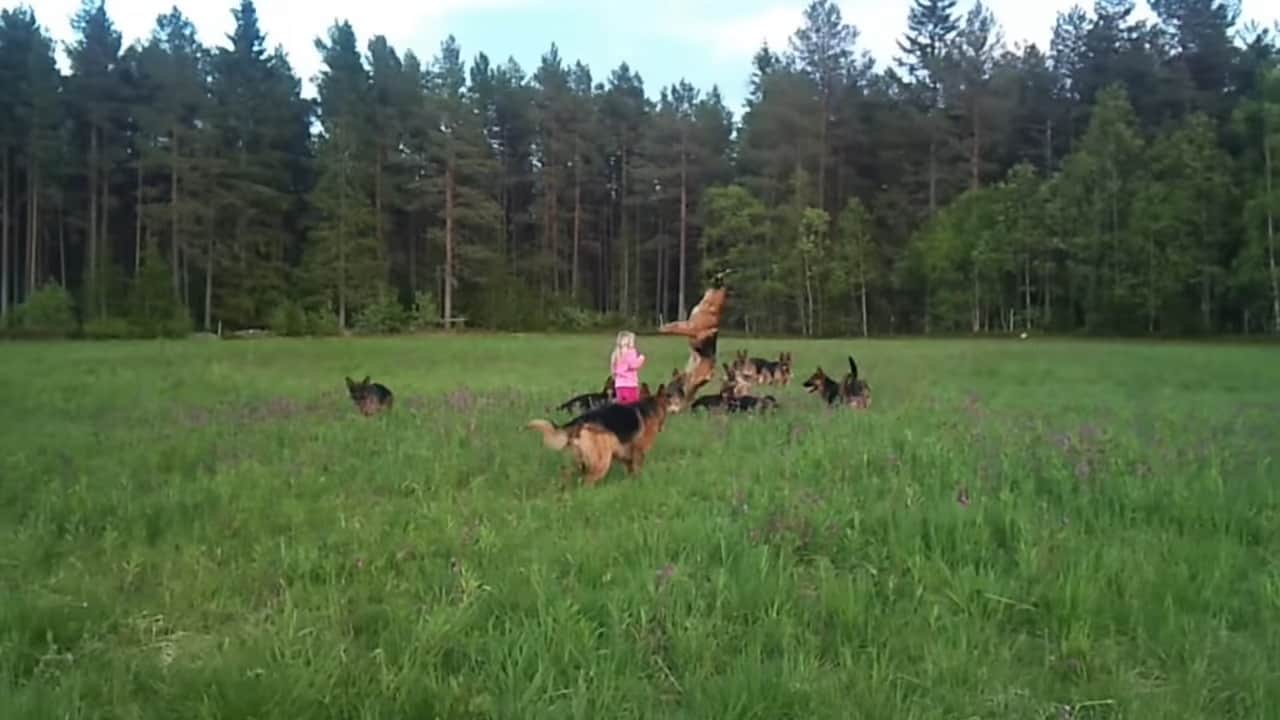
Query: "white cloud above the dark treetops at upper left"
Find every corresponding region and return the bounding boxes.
[36,0,530,94]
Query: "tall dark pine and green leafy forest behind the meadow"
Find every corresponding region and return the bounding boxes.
[0,0,1280,337]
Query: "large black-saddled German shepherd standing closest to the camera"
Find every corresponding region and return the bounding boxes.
[526,386,678,486]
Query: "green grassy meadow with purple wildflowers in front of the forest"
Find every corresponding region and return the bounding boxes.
[0,334,1280,720]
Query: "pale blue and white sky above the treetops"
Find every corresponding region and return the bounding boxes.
[27,0,1280,115]
